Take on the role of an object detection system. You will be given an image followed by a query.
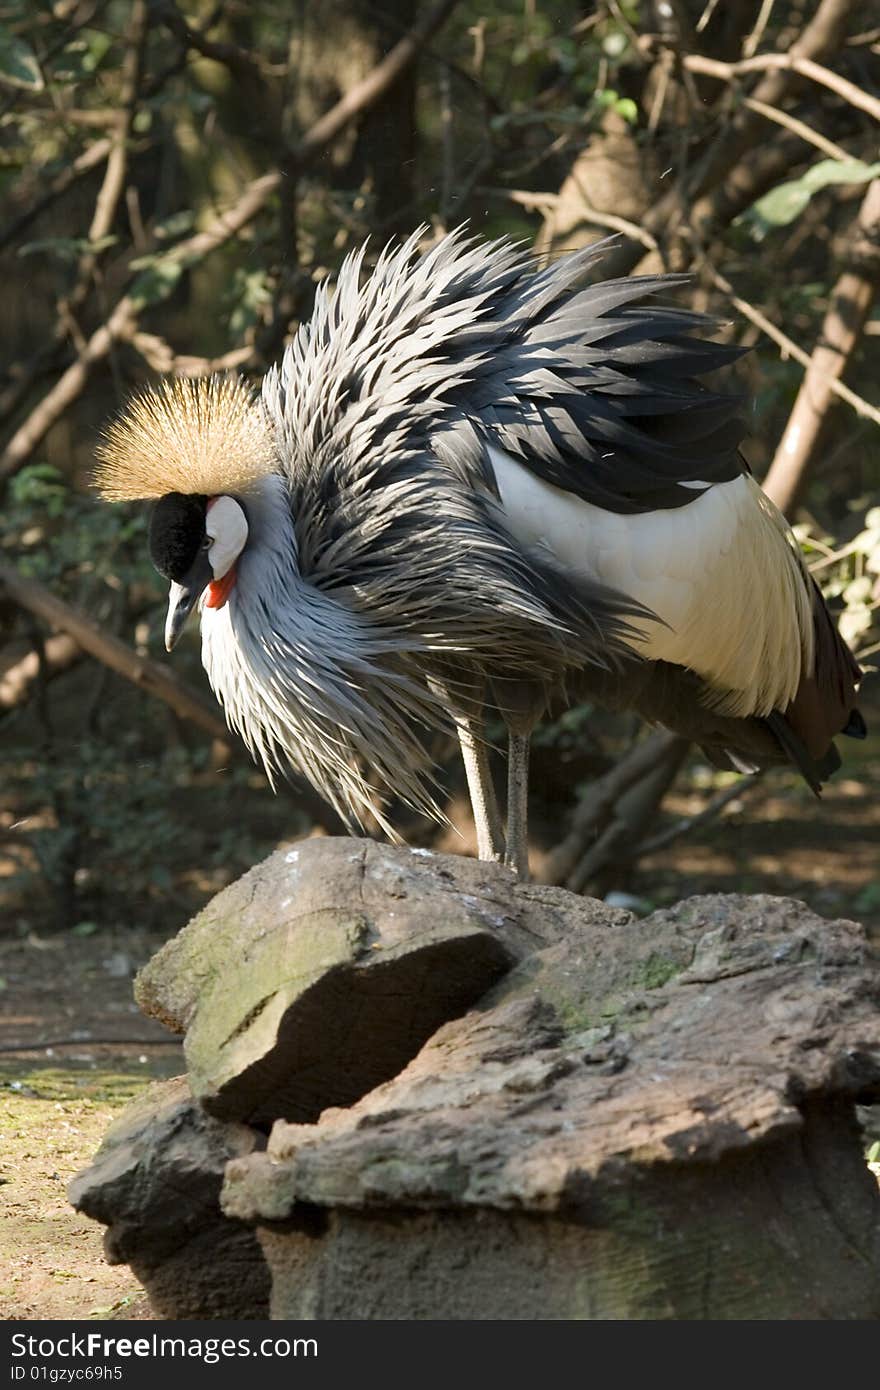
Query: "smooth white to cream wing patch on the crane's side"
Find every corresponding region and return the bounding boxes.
[489,448,813,716]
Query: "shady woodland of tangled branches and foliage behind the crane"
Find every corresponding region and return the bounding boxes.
[0,0,880,940]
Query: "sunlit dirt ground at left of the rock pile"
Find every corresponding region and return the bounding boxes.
[0,933,185,1321]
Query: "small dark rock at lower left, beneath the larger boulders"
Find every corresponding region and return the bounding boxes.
[68,1076,270,1319]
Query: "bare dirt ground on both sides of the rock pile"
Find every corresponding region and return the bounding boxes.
[0,739,880,1321]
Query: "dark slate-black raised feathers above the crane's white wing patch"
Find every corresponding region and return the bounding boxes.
[439,249,745,513]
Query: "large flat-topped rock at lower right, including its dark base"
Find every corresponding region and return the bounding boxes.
[222,897,880,1319]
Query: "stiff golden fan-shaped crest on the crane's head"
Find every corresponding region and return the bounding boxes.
[95,377,277,502]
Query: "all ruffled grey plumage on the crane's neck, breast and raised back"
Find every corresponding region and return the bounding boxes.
[227,232,756,831]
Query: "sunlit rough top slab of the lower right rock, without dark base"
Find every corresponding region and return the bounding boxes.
[224,895,880,1219]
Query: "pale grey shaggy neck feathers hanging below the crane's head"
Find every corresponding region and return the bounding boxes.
[202,477,445,837]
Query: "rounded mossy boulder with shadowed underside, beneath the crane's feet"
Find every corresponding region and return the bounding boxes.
[135,840,611,1127]
